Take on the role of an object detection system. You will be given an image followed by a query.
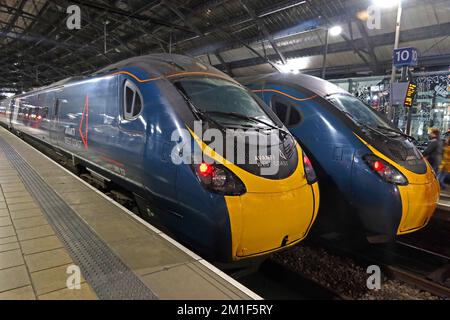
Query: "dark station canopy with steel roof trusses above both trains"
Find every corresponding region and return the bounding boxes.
[0,0,450,98]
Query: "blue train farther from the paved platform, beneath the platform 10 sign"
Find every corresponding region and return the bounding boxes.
[241,74,439,242]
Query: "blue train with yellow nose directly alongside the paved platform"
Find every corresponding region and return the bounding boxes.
[0,55,319,262]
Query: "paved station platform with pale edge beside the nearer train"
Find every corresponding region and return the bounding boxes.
[0,127,260,300]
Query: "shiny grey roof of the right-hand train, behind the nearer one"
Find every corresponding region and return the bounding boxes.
[238,73,349,97]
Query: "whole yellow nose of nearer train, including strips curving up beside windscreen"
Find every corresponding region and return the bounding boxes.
[194,132,319,260]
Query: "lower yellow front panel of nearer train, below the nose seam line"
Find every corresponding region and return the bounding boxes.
[225,184,319,258]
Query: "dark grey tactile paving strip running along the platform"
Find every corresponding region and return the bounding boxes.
[0,138,157,300]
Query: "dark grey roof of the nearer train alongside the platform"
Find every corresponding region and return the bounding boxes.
[11,53,233,99]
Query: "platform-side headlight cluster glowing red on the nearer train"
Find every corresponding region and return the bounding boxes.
[194,162,247,196]
